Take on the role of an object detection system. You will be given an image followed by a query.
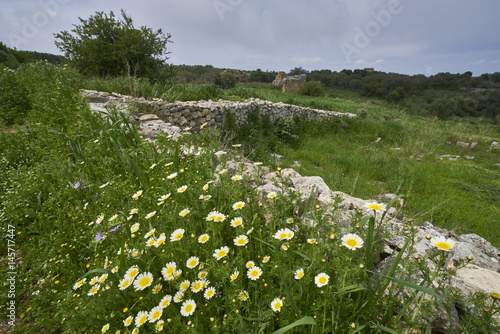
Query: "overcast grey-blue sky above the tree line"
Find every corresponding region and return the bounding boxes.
[0,0,500,76]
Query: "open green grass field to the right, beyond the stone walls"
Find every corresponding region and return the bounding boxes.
[220,85,500,246]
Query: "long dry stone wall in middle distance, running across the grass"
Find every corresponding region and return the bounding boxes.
[81,90,356,131]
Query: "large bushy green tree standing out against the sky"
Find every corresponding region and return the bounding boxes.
[54,9,171,79]
